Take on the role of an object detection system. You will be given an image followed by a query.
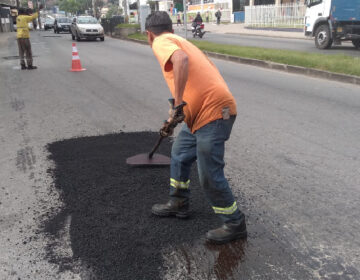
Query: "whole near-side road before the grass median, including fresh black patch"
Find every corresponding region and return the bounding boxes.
[0,32,360,280]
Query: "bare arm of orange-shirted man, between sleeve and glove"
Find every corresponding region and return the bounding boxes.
[170,50,189,107]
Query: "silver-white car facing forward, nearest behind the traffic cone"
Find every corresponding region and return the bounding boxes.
[70,16,105,41]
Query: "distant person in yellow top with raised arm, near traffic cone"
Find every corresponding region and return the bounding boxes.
[16,5,42,70]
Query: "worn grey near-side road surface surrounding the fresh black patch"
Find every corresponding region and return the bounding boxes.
[0,32,360,279]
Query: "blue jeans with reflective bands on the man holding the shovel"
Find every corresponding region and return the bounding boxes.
[170,116,244,223]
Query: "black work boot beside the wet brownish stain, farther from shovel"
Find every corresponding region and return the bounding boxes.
[206,219,247,244]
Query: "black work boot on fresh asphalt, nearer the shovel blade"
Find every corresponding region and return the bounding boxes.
[151,200,189,219]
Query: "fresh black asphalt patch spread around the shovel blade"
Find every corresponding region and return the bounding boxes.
[44,132,220,280]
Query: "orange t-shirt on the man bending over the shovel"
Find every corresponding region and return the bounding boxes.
[152,33,236,133]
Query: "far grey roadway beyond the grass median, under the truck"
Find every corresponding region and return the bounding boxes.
[176,28,360,56]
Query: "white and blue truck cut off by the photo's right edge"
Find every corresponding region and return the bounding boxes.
[305,0,360,49]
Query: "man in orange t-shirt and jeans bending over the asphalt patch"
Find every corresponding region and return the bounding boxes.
[145,11,247,244]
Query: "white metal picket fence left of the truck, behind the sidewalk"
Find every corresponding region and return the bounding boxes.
[245,4,306,28]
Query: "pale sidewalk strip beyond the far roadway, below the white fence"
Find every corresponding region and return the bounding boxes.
[173,23,307,39]
